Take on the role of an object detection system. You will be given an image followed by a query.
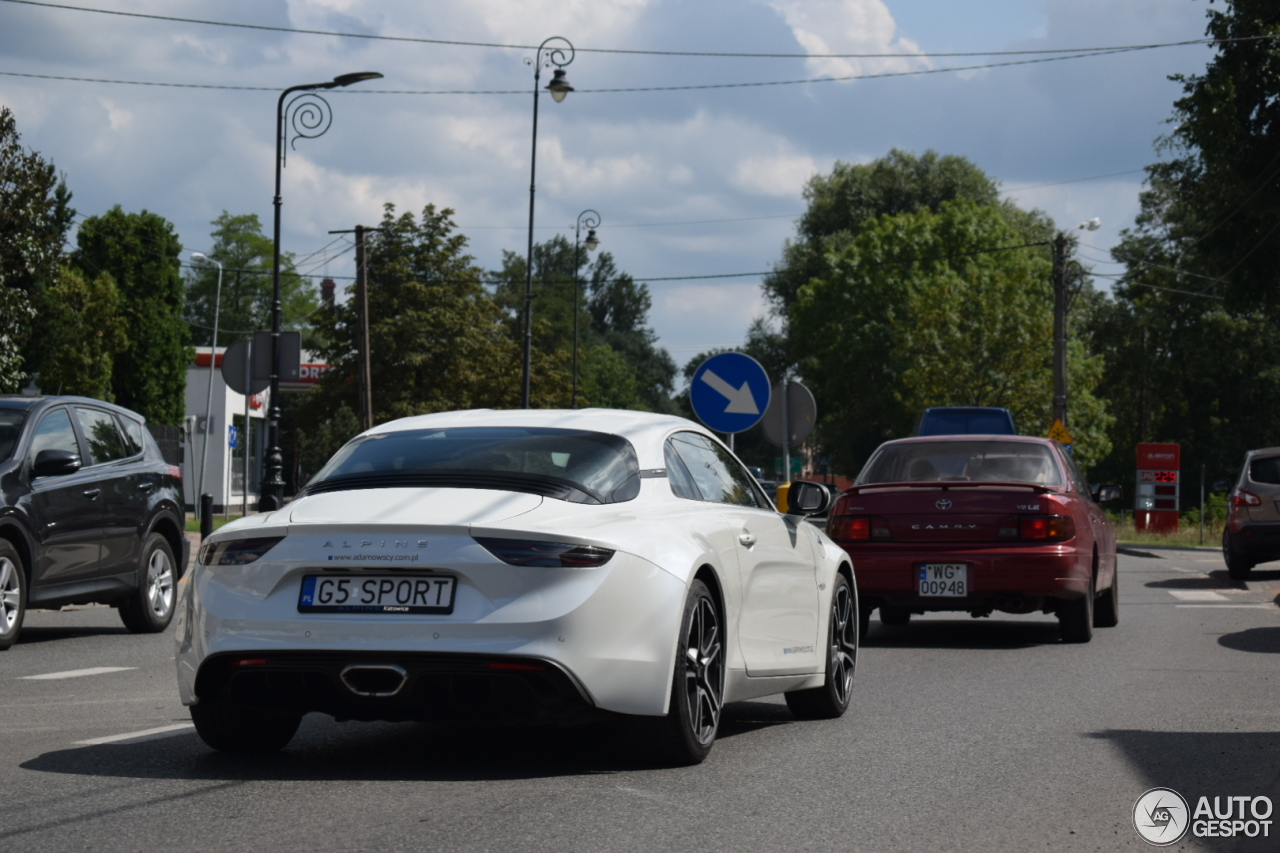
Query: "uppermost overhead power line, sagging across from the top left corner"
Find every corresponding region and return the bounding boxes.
[3,0,1259,58]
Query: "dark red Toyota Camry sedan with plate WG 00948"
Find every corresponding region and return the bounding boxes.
[827,435,1120,643]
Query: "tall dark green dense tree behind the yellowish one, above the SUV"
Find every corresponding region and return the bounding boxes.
[72,205,192,424]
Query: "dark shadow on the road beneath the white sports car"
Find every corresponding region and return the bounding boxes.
[17,702,795,778]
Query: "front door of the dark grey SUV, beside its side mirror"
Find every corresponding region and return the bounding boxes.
[26,407,102,591]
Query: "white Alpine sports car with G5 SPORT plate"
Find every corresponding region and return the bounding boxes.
[175,410,859,763]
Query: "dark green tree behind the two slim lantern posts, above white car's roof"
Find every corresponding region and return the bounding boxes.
[489,234,676,411]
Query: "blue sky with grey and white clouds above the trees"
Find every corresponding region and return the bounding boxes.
[0,0,1211,362]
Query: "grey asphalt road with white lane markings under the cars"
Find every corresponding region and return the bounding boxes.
[0,551,1280,853]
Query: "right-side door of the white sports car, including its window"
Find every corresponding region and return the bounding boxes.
[668,433,822,675]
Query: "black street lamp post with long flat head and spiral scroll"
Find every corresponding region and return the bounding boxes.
[257,72,381,512]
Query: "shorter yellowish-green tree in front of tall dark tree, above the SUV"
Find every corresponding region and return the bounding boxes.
[40,269,128,401]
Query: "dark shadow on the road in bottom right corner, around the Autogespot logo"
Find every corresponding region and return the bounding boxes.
[1087,729,1280,850]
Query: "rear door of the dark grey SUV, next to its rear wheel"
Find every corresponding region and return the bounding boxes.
[73,406,147,576]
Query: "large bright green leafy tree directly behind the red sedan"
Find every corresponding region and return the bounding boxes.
[791,200,1110,470]
